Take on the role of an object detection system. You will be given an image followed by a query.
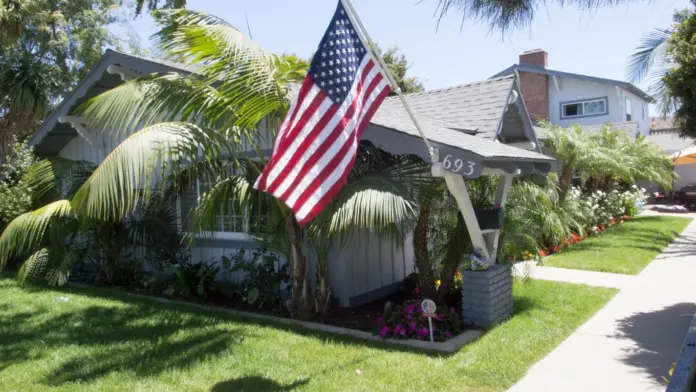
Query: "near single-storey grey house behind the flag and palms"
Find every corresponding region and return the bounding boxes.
[31,50,553,306]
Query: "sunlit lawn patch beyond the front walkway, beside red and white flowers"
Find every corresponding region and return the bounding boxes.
[543,216,691,275]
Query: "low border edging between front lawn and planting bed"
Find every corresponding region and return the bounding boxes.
[70,282,483,353]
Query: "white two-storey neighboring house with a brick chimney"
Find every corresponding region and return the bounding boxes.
[493,49,653,135]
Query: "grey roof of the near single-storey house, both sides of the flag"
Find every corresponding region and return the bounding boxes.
[31,50,553,172]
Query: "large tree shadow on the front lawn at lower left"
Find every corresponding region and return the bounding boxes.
[0,286,252,386]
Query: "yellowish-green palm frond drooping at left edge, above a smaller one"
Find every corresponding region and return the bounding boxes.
[0,200,73,269]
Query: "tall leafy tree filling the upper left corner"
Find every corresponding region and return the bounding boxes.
[0,0,120,158]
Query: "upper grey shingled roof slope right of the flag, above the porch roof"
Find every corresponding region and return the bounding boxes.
[378,75,515,139]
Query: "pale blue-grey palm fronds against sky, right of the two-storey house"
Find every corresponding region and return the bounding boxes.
[626,28,676,115]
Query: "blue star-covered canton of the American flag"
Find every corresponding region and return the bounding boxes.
[309,2,367,106]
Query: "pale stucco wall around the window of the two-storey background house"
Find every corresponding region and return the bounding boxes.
[549,77,650,134]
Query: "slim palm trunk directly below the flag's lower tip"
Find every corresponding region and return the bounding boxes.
[285,211,313,318]
